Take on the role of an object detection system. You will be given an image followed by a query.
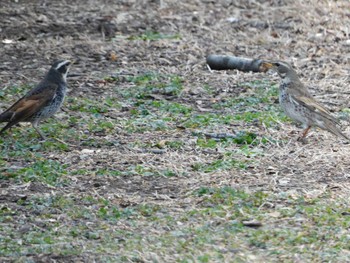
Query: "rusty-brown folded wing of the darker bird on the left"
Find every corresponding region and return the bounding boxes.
[0,85,57,126]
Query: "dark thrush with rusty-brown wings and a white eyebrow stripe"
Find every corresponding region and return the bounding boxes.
[0,60,72,140]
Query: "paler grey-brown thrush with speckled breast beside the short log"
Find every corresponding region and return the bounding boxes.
[260,61,349,141]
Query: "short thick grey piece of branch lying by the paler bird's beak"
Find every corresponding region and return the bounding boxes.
[207,55,268,72]
